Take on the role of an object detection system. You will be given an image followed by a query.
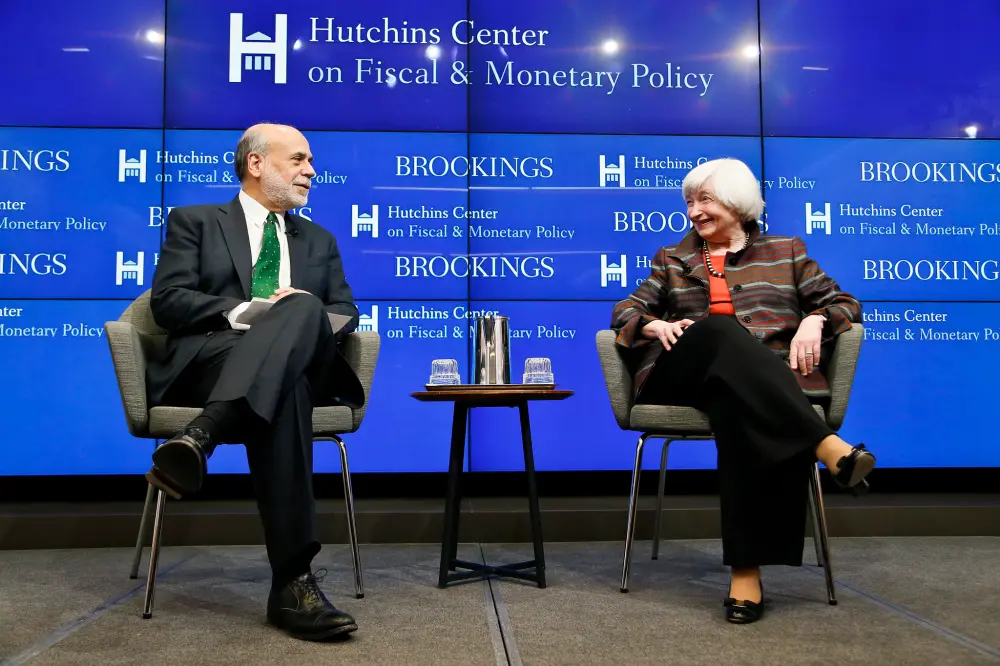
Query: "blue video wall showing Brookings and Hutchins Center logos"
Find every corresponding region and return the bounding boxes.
[0,0,1000,476]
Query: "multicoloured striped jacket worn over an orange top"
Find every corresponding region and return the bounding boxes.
[611,224,861,398]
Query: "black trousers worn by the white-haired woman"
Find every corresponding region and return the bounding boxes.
[637,315,833,567]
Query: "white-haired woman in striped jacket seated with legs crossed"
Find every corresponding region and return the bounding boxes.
[611,159,875,623]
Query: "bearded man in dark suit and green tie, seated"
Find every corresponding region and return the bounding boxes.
[146,125,365,640]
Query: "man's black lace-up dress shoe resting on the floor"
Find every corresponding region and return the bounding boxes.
[267,573,358,641]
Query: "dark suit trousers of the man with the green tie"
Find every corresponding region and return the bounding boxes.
[164,294,336,584]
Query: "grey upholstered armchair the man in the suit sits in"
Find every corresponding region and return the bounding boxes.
[104,291,380,619]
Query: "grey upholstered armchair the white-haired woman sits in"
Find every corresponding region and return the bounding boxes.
[597,324,864,604]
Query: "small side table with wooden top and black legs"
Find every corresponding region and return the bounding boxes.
[411,384,573,587]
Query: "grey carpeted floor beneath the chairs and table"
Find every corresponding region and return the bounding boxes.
[0,538,1000,666]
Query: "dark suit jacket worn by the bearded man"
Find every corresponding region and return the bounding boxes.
[147,197,364,407]
